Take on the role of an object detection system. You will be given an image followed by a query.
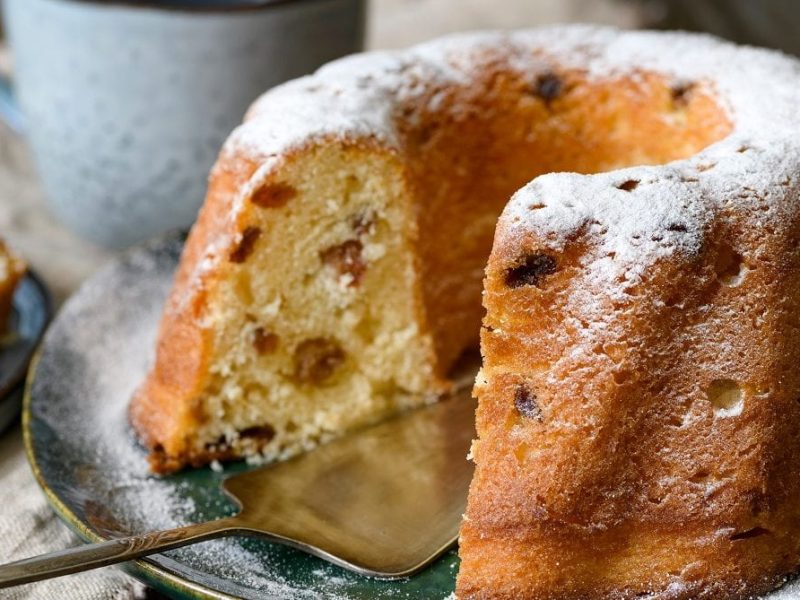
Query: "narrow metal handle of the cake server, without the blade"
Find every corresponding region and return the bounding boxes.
[0,517,244,589]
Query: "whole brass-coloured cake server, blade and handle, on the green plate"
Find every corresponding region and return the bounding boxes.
[0,390,475,588]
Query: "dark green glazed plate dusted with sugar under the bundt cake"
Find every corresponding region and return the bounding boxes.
[23,235,458,600]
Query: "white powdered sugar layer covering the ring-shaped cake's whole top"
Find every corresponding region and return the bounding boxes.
[189,25,800,312]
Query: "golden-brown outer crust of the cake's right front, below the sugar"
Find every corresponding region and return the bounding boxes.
[457,146,800,600]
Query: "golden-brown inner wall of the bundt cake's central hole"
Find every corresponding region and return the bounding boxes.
[398,61,730,371]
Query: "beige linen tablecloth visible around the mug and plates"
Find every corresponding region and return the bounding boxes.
[0,0,636,600]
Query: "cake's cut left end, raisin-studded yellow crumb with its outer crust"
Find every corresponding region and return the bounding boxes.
[132,144,447,472]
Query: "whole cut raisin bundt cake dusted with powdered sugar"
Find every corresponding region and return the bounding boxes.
[131,26,800,599]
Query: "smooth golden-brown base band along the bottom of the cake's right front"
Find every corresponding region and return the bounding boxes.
[458,523,799,600]
